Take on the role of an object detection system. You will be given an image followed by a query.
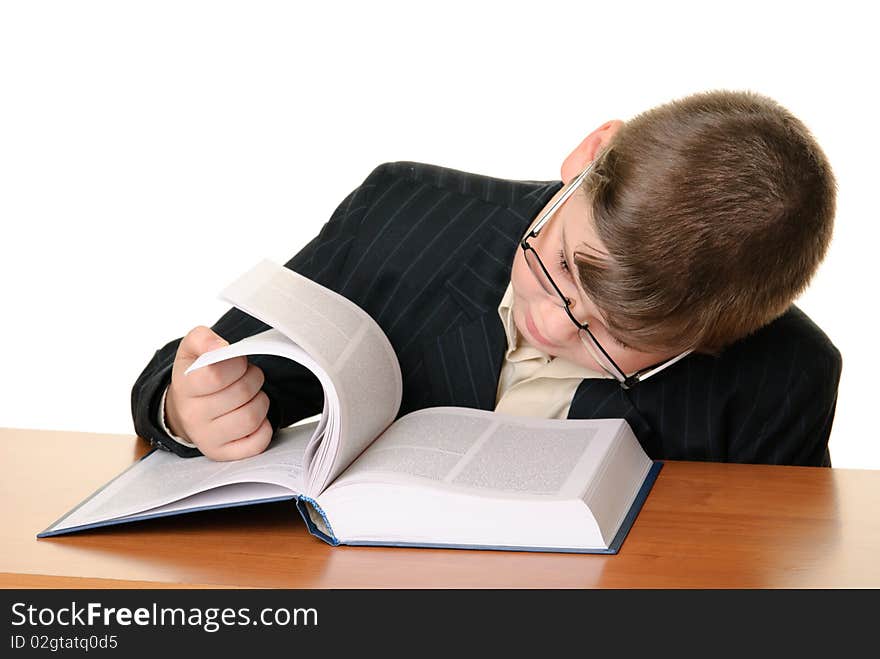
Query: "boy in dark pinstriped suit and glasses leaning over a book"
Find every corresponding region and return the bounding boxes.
[132,91,841,466]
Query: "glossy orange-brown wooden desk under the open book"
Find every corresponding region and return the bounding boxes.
[0,429,880,588]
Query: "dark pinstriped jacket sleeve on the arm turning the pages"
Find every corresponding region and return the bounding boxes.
[131,165,387,457]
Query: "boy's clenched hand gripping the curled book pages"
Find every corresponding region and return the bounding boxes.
[165,325,272,460]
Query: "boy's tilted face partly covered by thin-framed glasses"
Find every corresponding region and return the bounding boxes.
[511,190,674,374]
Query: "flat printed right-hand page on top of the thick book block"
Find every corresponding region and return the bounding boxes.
[328,407,620,497]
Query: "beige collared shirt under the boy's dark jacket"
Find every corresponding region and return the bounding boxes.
[495,283,611,419]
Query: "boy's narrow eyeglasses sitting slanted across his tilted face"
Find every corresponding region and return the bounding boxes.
[520,162,693,389]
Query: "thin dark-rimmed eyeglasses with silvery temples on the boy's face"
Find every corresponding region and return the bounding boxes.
[519,162,693,389]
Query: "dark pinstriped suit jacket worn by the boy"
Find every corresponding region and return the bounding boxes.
[131,162,841,466]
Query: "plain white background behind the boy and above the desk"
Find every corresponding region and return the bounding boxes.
[0,0,880,469]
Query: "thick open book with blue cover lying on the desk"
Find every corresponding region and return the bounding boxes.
[37,261,662,553]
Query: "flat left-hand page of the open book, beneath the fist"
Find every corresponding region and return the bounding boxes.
[46,422,316,531]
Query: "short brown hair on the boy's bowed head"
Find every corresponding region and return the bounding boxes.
[575,91,835,354]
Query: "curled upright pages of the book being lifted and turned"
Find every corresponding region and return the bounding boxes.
[188,261,403,496]
